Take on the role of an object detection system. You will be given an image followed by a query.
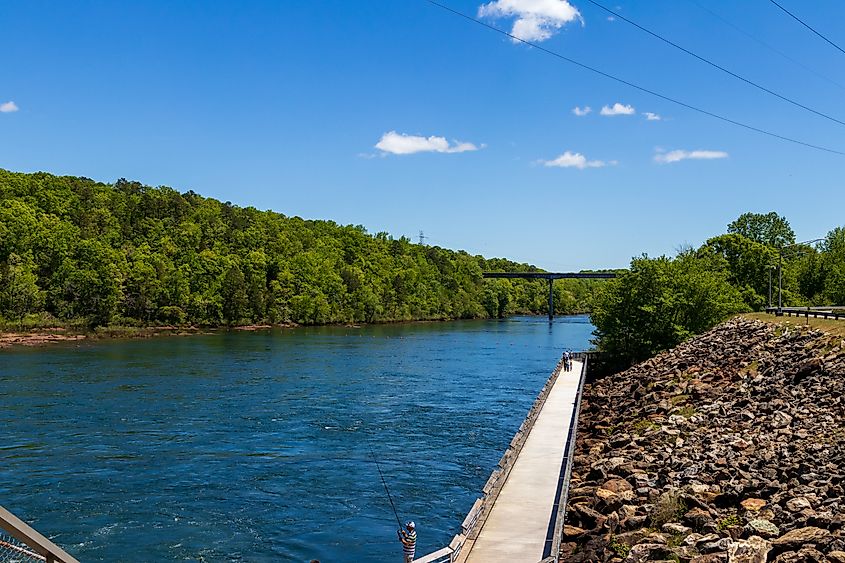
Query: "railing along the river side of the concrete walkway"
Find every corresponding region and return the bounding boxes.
[414,352,576,563]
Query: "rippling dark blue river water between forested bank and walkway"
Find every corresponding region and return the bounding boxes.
[0,317,593,563]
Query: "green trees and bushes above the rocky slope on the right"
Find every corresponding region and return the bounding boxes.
[591,212,845,367]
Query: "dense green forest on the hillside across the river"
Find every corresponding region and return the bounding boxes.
[0,169,600,330]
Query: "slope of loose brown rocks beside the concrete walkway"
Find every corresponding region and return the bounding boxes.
[561,319,845,563]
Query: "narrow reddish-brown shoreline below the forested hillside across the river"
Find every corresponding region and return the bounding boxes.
[0,312,589,350]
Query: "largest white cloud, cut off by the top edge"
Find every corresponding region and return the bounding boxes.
[478,0,584,41]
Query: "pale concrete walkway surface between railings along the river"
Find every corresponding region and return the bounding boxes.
[464,362,581,563]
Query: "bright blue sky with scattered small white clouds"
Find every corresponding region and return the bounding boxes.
[0,0,845,270]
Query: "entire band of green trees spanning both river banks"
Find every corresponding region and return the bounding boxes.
[0,169,845,365]
